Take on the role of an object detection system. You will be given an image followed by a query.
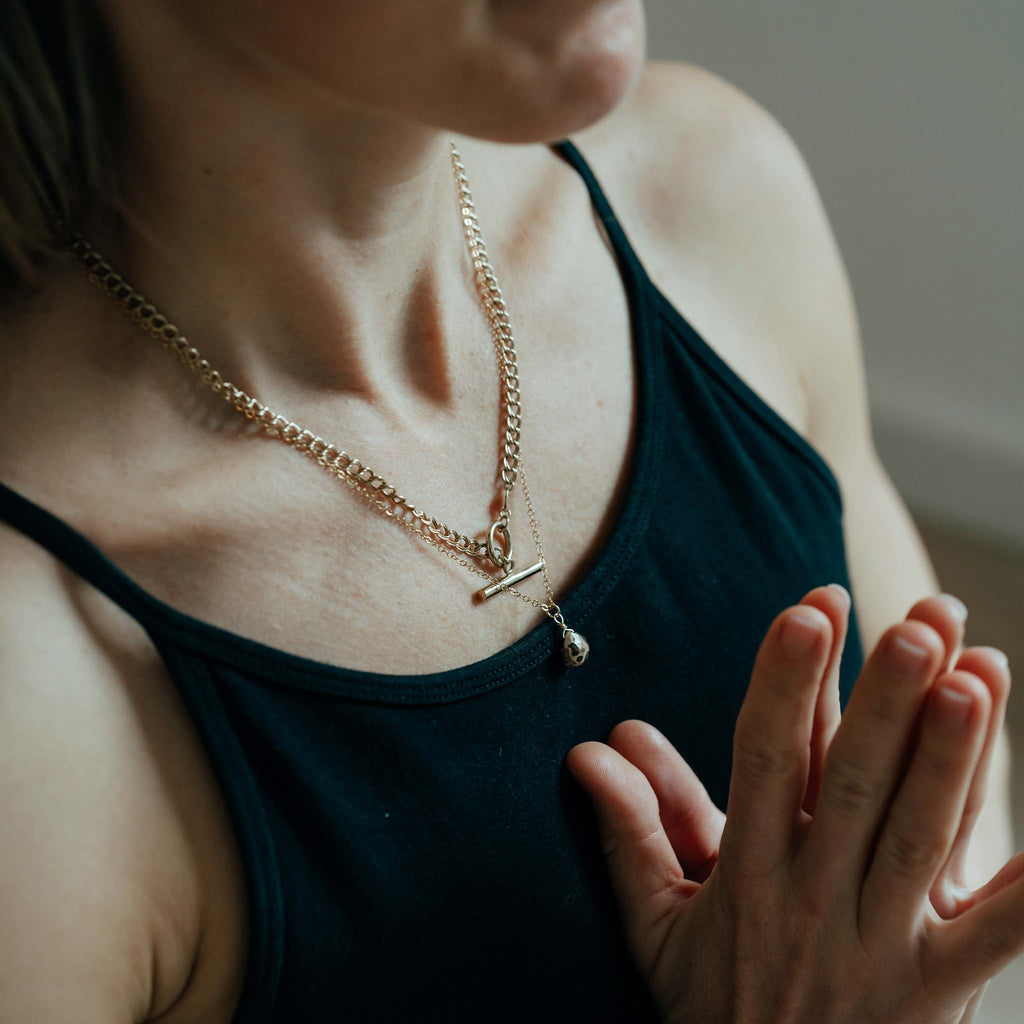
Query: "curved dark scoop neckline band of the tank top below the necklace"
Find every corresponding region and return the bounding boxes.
[0,140,663,703]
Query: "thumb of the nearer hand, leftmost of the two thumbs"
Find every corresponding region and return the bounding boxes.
[565,742,698,937]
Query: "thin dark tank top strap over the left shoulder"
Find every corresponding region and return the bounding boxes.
[0,482,162,631]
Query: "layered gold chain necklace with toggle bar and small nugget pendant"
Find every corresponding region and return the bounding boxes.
[66,142,590,666]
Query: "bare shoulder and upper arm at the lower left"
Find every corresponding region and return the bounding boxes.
[0,525,243,1024]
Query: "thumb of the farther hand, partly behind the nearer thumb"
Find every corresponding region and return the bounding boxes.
[608,721,725,882]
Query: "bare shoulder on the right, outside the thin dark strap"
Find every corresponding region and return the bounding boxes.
[579,61,866,447]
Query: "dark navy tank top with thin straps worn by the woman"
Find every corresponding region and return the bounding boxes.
[0,141,862,1024]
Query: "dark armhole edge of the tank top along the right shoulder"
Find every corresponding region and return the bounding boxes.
[552,139,843,515]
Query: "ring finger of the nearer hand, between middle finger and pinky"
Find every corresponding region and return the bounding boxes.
[860,671,990,945]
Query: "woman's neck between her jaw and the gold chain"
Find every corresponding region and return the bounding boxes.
[88,4,520,418]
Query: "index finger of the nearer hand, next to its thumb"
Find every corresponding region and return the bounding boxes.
[722,605,831,878]
